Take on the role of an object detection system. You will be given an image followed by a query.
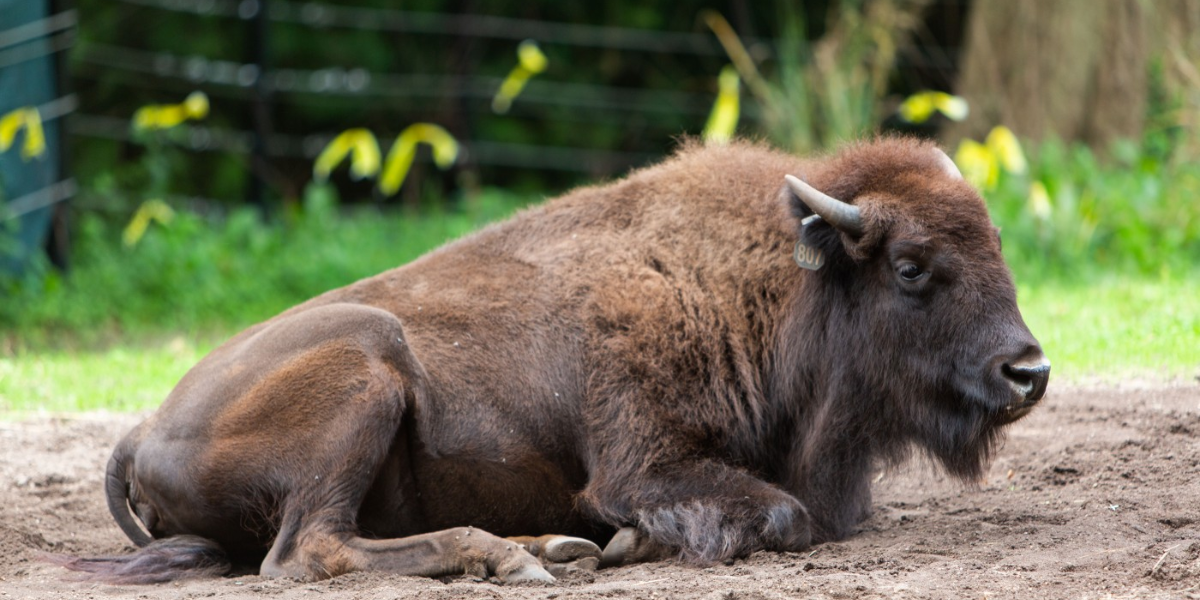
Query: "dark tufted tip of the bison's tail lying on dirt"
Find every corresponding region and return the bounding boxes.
[46,535,233,583]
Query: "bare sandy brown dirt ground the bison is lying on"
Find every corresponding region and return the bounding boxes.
[0,380,1200,600]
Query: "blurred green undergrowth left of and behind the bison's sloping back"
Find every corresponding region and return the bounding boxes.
[0,185,532,354]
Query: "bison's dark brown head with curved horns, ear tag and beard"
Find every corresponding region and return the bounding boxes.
[786,140,1050,480]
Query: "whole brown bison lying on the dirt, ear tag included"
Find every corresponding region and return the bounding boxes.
[62,138,1050,582]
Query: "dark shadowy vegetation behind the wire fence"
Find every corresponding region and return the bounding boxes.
[68,0,966,202]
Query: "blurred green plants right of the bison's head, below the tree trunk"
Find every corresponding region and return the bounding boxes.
[985,137,1200,283]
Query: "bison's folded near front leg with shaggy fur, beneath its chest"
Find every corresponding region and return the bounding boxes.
[583,461,811,566]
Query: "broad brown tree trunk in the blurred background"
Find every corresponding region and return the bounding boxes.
[943,0,1147,152]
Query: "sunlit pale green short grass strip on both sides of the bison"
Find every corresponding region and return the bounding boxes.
[0,278,1200,416]
